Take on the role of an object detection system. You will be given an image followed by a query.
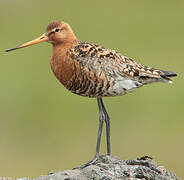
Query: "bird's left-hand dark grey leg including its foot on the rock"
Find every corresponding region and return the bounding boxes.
[74,98,105,169]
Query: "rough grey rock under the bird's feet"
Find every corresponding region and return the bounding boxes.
[0,155,179,180]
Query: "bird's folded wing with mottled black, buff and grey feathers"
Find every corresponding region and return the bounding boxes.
[70,41,164,80]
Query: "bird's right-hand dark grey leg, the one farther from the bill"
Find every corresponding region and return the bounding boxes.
[99,98,111,156]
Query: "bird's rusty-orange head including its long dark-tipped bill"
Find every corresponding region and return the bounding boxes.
[6,21,76,52]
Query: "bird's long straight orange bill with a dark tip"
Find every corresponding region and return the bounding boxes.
[5,34,48,52]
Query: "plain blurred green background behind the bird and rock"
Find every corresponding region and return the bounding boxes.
[0,0,184,178]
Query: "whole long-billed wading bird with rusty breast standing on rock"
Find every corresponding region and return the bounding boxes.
[6,21,177,167]
